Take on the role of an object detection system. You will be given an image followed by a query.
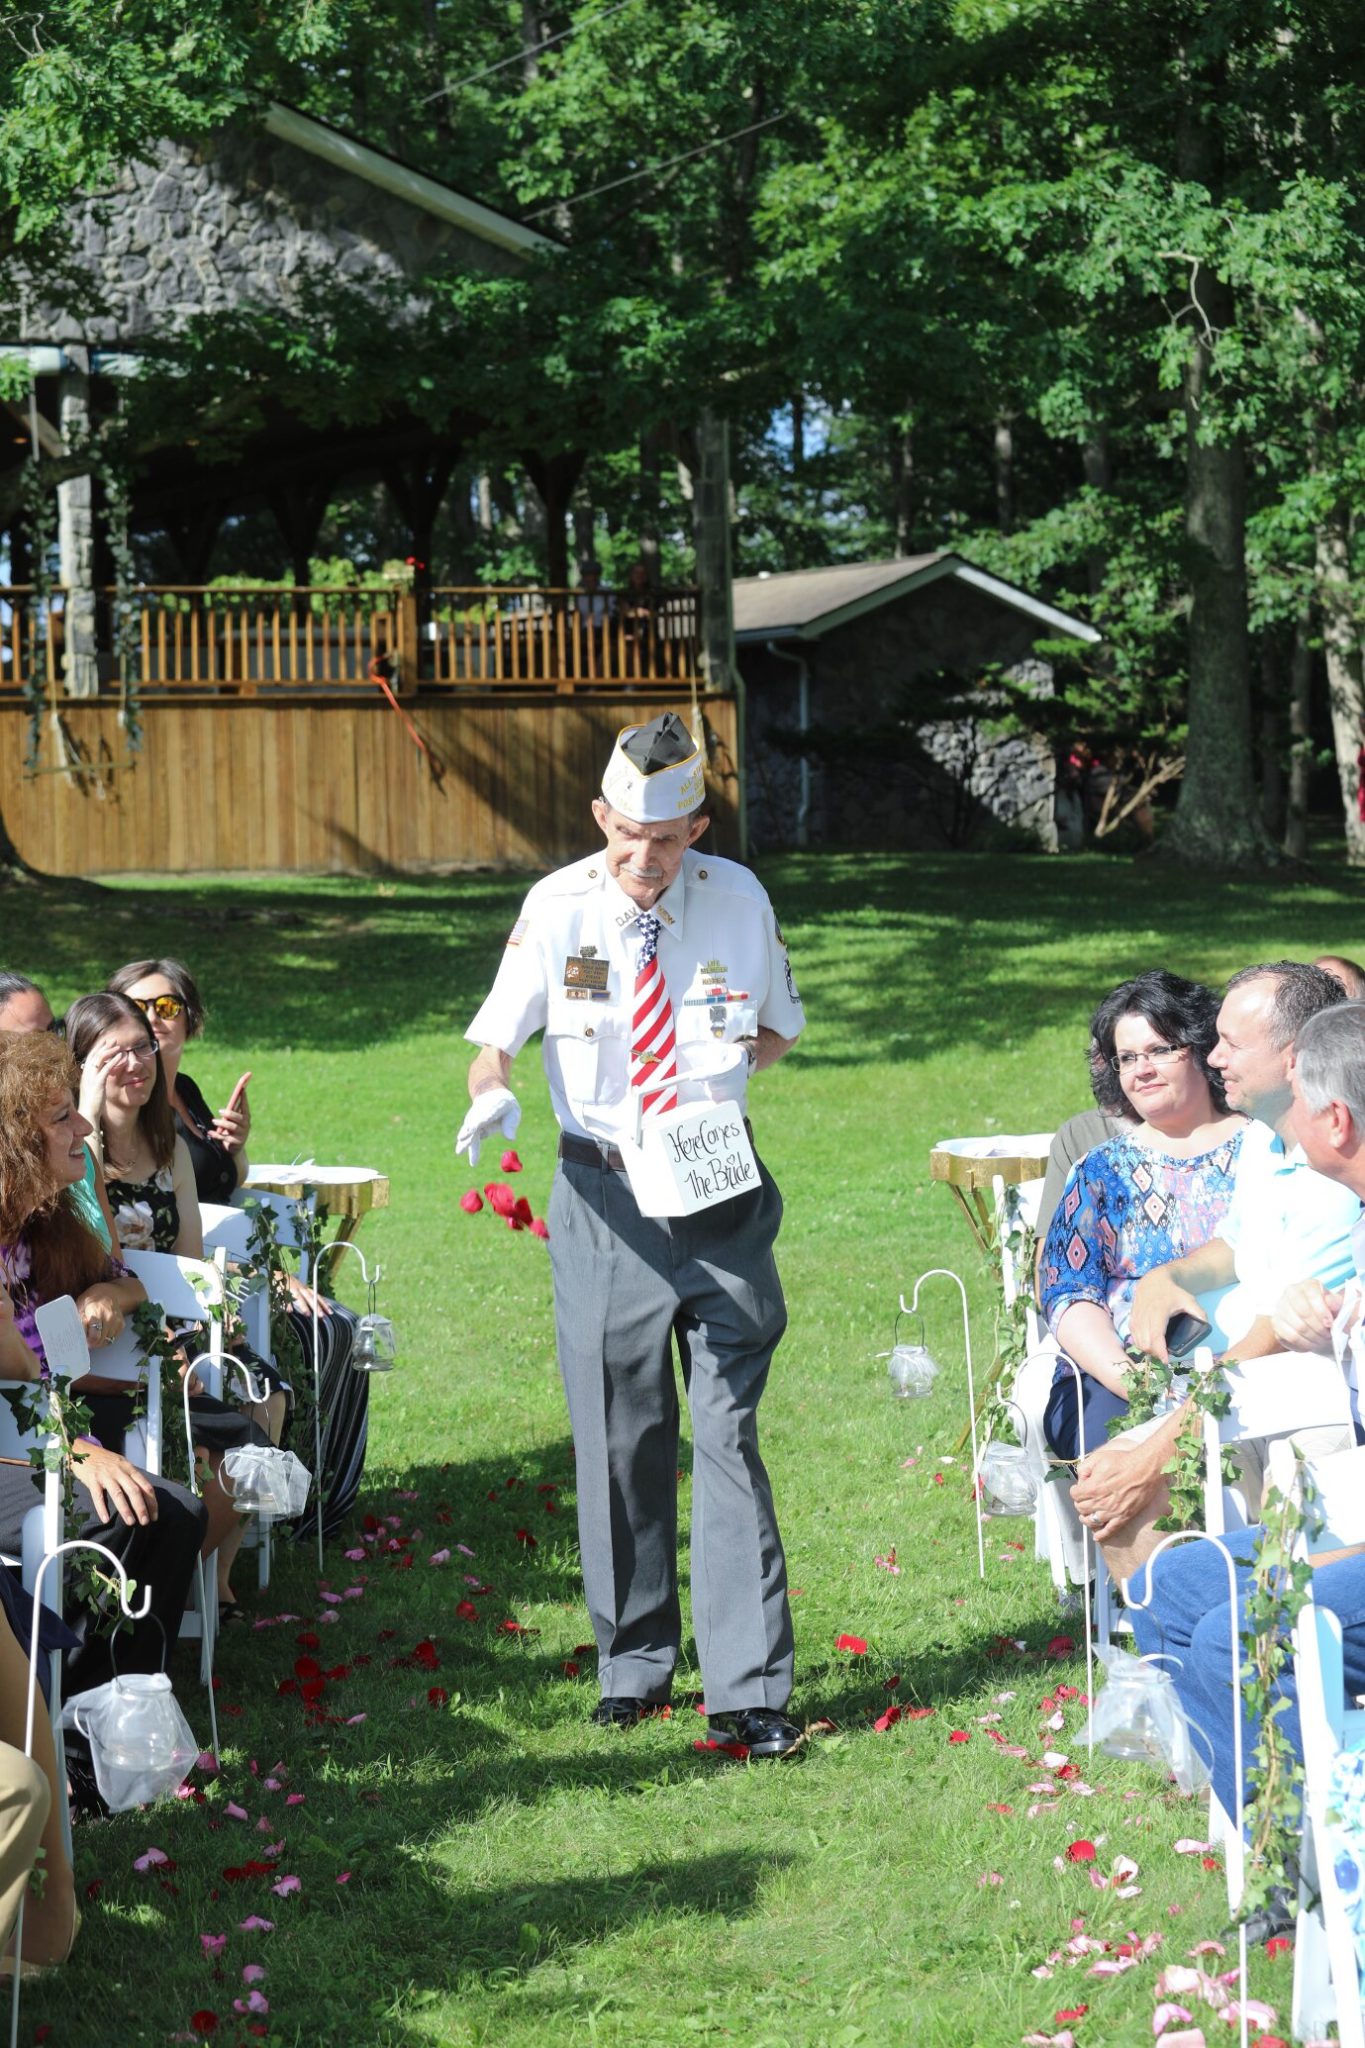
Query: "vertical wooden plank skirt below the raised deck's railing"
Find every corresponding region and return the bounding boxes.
[0,684,737,874]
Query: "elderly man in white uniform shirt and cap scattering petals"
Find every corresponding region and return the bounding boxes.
[456,713,804,1757]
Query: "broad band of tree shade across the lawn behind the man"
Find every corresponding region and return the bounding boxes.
[15,851,1365,1067]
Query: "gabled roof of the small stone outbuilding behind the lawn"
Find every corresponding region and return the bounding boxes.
[735,555,1101,645]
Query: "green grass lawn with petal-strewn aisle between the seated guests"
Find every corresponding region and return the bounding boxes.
[0,854,1365,2048]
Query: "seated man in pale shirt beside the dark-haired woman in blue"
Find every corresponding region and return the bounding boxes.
[1072,961,1361,1579]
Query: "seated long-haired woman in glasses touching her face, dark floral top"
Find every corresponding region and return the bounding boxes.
[65,995,272,1620]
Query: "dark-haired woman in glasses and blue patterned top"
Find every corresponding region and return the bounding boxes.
[1040,969,1246,1460]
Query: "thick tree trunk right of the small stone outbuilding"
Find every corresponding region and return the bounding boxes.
[1166,262,1277,866]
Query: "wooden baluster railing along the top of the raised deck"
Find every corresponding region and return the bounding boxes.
[0,584,698,696]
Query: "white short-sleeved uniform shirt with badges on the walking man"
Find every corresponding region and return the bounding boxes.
[465,852,806,1143]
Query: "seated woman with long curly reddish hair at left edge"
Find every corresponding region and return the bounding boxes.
[0,1032,205,1802]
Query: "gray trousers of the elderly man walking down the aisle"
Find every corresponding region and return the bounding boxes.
[548,1159,792,1712]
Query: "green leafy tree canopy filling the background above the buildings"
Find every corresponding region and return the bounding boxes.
[0,0,1365,860]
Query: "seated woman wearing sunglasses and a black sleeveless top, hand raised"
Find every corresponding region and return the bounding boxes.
[108,961,370,1534]
